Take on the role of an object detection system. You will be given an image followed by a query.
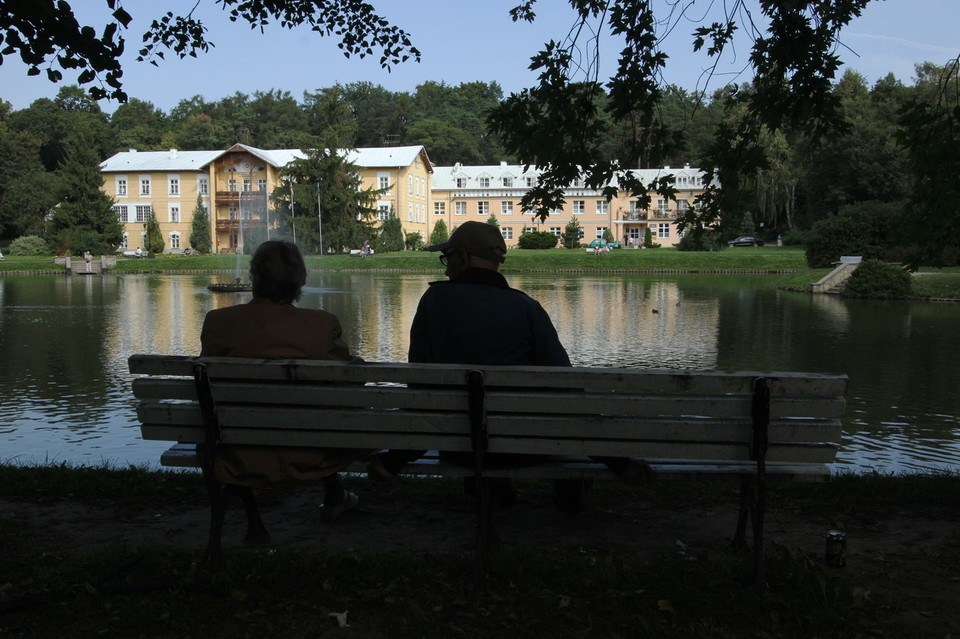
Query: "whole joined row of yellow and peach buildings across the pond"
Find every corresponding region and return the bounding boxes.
[101,144,704,254]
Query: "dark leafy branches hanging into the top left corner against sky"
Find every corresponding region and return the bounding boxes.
[0,0,420,102]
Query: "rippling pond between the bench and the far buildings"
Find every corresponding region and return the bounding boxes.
[0,273,960,472]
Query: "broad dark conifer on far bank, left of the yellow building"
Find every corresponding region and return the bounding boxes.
[48,130,123,255]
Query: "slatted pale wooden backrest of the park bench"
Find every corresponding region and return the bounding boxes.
[129,355,847,463]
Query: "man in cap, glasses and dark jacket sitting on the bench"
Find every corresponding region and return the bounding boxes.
[368,222,652,514]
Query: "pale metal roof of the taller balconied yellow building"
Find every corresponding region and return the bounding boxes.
[100,144,433,173]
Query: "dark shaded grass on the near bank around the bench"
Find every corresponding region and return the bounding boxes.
[0,466,960,639]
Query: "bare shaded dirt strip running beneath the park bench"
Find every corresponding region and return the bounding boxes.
[7,480,960,637]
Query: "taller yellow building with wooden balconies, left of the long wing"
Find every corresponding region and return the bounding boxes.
[100,144,433,254]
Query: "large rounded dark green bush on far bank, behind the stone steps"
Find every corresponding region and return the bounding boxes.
[806,202,903,268]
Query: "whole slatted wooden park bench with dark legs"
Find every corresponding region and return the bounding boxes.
[129,355,847,581]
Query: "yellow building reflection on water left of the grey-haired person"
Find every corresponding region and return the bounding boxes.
[106,275,216,357]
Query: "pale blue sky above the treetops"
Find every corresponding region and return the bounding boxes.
[0,0,960,113]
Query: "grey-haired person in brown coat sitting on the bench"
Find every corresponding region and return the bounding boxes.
[200,240,369,521]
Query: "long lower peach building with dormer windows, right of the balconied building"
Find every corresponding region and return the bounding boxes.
[425,162,704,247]
